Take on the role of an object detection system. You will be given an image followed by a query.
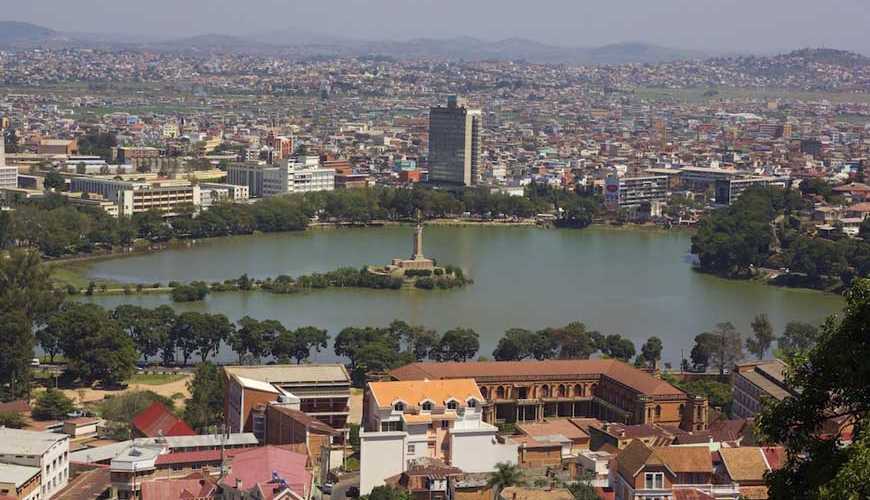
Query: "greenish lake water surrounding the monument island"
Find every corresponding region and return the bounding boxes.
[80,226,844,366]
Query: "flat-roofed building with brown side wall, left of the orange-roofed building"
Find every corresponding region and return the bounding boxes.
[224,363,350,435]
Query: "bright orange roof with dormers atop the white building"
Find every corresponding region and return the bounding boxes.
[369,378,483,408]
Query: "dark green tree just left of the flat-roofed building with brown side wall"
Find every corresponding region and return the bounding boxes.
[184,363,226,431]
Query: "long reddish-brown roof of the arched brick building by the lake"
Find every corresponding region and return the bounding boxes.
[390,359,685,395]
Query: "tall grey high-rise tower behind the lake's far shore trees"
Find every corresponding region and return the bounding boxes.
[429,96,483,186]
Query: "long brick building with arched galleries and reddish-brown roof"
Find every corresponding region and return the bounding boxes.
[390,359,708,431]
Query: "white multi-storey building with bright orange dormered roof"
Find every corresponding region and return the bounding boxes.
[360,379,517,495]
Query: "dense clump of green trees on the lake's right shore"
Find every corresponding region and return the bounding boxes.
[692,187,870,289]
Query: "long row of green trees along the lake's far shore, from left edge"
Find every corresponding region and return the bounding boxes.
[0,186,598,258]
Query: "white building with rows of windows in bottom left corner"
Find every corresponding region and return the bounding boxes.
[0,427,69,500]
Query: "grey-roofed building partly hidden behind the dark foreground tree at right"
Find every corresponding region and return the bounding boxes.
[733,359,794,418]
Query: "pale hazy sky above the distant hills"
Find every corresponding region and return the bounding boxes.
[6,0,870,53]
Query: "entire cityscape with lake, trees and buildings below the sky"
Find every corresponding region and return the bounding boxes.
[0,8,870,500]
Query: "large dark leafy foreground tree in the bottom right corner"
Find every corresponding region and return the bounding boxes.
[758,279,870,499]
